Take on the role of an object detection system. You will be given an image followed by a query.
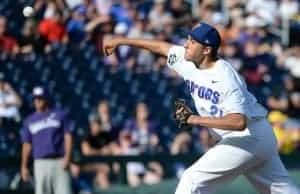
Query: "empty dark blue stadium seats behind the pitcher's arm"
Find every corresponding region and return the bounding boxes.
[3,39,187,150]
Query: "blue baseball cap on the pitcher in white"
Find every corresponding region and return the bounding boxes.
[189,22,221,49]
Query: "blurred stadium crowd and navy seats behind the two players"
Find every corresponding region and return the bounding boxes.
[0,0,300,194]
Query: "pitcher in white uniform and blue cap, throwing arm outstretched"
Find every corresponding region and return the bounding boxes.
[103,22,300,194]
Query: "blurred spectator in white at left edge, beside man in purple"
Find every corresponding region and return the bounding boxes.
[0,72,22,122]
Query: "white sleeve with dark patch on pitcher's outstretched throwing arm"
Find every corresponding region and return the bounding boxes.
[167,46,195,79]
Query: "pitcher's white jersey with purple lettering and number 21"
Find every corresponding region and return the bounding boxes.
[167,46,267,139]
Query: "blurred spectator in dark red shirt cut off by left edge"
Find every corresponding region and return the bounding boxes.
[0,15,19,54]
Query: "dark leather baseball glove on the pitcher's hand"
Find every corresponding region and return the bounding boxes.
[174,99,193,130]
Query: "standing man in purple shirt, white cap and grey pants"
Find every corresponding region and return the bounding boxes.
[21,87,72,194]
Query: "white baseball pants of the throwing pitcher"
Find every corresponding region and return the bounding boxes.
[175,119,300,194]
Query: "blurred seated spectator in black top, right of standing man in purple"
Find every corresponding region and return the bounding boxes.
[81,120,112,189]
